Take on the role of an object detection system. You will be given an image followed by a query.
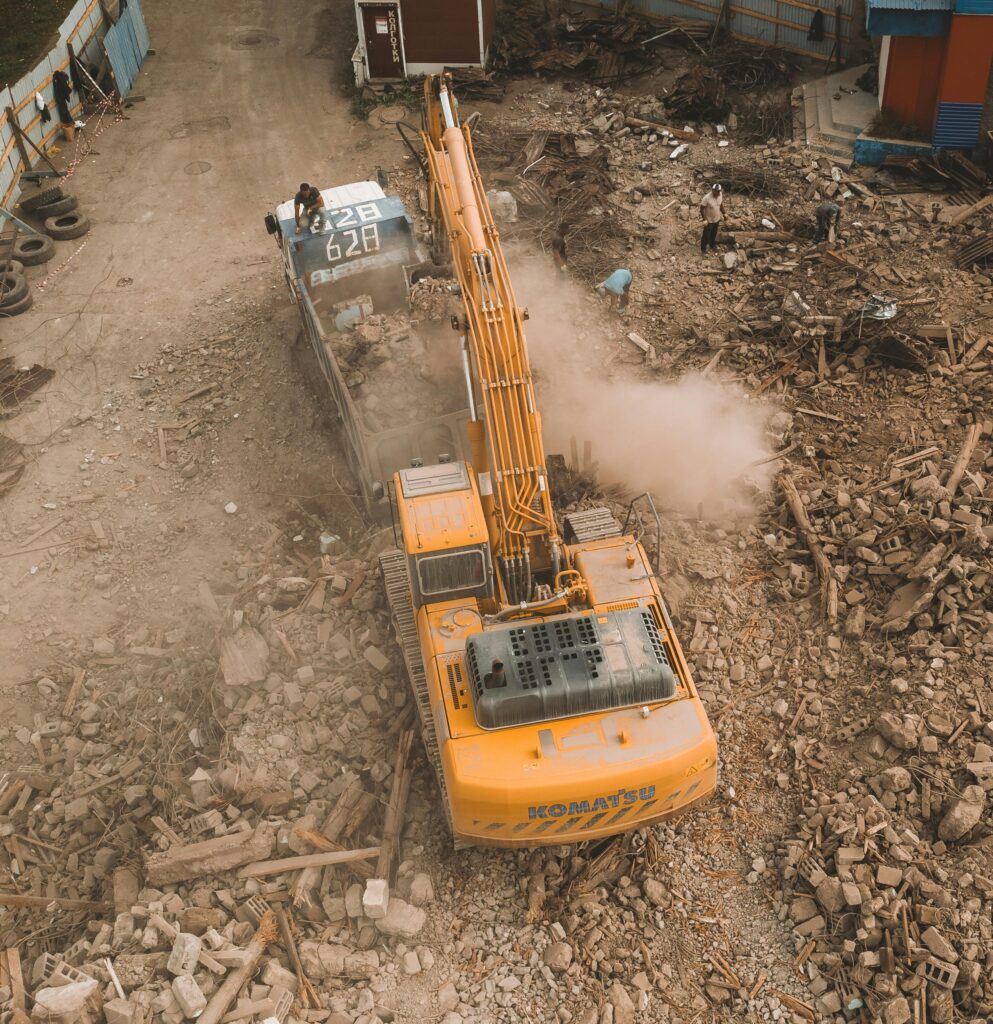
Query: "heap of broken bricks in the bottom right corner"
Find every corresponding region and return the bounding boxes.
[780,713,993,1024]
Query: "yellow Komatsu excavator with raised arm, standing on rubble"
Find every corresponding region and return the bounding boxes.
[380,76,718,847]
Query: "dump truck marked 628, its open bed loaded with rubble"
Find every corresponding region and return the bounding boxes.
[265,181,469,519]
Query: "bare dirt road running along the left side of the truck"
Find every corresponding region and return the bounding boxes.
[0,0,396,688]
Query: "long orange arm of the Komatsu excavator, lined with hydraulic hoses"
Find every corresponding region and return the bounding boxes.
[422,76,560,605]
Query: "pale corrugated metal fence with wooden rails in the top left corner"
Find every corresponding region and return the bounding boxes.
[0,0,132,208]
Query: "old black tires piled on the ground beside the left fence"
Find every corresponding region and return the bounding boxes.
[0,185,90,319]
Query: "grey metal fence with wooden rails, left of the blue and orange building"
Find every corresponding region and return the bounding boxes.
[603,0,855,60]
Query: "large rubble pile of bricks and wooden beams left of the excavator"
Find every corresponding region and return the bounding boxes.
[0,539,444,1024]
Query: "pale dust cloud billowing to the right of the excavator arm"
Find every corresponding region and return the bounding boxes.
[511,257,772,514]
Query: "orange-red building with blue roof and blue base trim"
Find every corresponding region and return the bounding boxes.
[866,0,993,150]
